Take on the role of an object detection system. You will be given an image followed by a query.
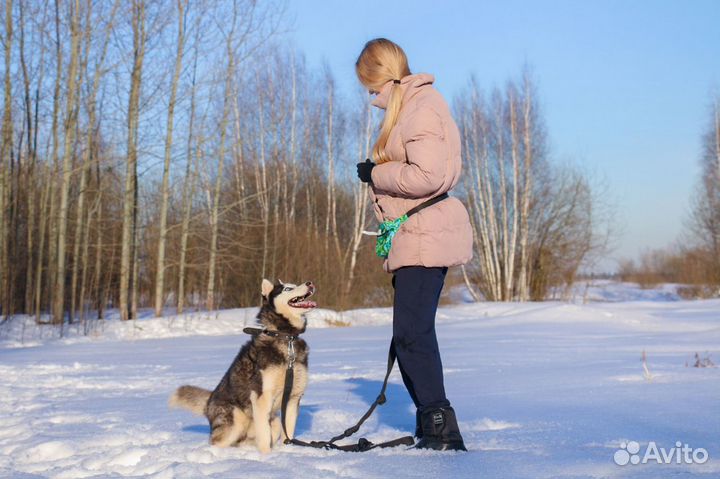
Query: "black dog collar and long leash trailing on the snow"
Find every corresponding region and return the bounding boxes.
[243,328,415,452]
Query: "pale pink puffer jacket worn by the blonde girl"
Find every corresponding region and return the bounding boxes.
[371,73,473,272]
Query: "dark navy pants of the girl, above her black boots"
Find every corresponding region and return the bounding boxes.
[392,266,450,412]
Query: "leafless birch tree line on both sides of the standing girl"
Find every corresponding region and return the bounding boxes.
[0,0,605,324]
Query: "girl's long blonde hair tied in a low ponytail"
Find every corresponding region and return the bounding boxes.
[355,38,410,164]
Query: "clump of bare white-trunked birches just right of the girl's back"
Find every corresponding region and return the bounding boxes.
[455,67,607,301]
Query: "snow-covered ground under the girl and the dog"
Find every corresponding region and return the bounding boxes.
[0,284,720,479]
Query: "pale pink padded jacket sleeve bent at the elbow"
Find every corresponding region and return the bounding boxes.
[372,107,447,198]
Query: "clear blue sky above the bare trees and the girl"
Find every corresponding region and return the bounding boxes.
[288,0,720,266]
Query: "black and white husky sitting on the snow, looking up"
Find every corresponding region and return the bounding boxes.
[169,279,317,453]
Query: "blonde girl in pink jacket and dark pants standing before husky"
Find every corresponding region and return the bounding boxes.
[355,38,472,451]
